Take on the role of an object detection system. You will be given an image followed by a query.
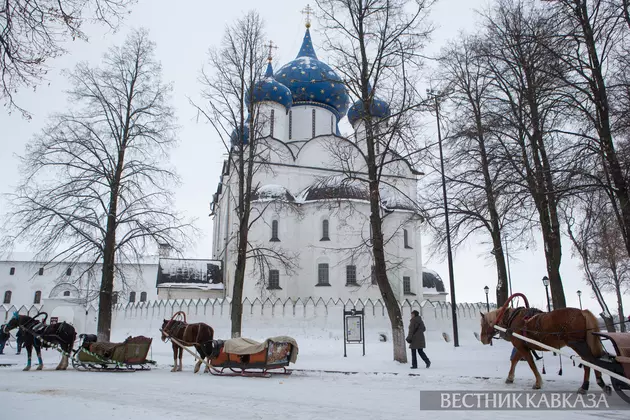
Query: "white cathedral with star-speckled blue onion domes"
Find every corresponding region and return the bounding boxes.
[211,24,446,301]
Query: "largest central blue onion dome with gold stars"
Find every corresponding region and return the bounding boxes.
[276,27,350,120]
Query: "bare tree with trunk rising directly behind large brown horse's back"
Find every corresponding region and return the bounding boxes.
[484,0,572,308]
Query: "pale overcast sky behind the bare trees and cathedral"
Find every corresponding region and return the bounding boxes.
[0,0,630,314]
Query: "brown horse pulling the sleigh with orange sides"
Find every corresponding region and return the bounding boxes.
[162,319,214,373]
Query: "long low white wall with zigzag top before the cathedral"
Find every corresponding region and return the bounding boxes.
[0,298,496,340]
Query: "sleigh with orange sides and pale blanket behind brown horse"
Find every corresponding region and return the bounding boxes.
[208,336,298,378]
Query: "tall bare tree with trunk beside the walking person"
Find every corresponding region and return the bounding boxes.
[316,0,433,363]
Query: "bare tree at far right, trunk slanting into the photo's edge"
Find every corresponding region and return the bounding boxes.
[546,0,630,264]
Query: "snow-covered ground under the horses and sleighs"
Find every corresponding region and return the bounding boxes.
[0,331,630,420]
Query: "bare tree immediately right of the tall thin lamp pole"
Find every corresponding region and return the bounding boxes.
[422,36,526,305]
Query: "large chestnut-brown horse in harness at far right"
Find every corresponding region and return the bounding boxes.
[480,307,611,394]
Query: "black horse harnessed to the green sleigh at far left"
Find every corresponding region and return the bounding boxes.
[4,312,77,371]
